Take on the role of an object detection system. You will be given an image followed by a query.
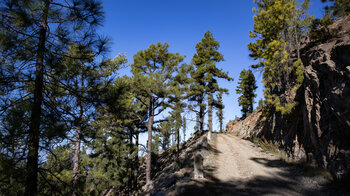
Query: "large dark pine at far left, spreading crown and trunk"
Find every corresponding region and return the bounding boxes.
[0,0,103,195]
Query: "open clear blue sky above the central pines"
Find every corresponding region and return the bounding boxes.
[101,0,324,144]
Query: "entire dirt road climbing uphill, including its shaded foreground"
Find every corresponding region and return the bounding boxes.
[165,134,346,196]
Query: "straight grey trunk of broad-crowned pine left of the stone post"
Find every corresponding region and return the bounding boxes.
[146,97,154,185]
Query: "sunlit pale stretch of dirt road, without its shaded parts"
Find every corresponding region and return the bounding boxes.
[214,134,283,181]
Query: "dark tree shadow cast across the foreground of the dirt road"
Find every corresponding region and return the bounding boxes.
[171,148,350,196]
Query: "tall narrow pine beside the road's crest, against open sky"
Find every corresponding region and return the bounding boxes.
[189,31,232,132]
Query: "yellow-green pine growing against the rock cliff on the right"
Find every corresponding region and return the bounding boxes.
[248,0,311,114]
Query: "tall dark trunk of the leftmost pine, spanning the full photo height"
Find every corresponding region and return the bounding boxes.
[25,0,50,196]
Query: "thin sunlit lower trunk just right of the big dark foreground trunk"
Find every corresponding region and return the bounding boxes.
[73,126,81,196]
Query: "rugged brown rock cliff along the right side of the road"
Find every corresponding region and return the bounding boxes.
[228,16,350,179]
